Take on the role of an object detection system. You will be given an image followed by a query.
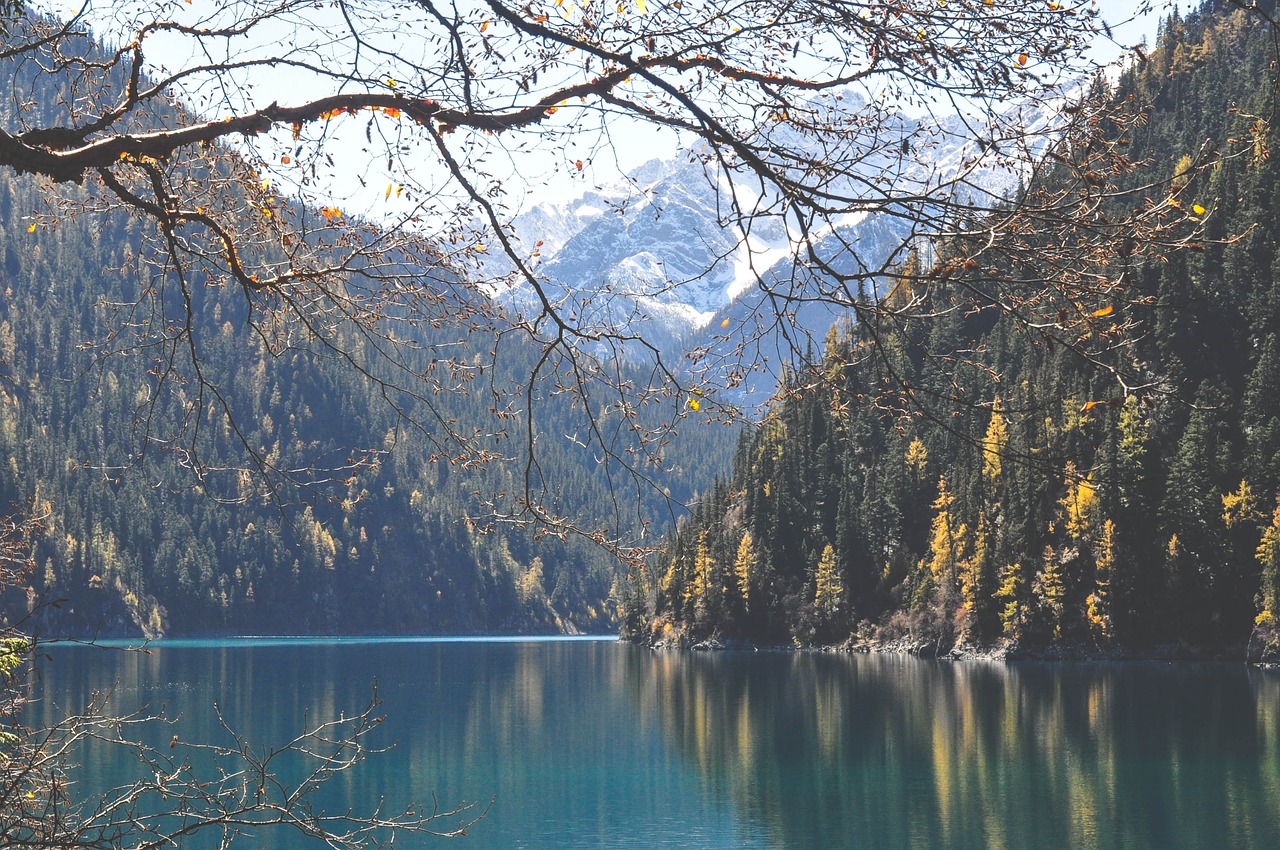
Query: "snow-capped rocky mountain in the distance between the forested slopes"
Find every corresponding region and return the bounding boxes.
[490,94,1053,403]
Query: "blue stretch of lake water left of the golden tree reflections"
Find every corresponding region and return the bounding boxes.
[40,641,767,850]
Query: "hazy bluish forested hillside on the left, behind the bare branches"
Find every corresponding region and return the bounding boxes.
[0,33,731,635]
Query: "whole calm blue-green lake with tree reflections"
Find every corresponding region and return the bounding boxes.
[27,639,1280,850]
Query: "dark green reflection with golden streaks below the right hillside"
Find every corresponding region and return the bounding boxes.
[630,653,1280,850]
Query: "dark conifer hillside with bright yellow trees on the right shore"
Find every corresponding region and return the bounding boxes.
[625,3,1280,652]
